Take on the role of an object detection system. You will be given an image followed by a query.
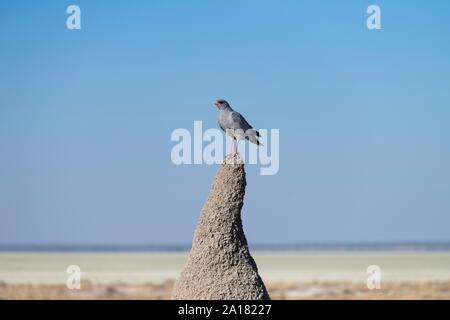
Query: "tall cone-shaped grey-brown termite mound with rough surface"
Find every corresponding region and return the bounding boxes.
[172,155,270,300]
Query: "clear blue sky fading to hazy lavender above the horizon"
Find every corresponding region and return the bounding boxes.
[0,0,450,244]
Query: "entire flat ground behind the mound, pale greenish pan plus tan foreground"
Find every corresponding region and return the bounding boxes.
[0,251,450,300]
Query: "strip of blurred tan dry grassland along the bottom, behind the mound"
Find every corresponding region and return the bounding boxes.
[0,280,450,300]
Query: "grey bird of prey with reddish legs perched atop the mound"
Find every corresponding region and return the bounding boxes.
[214,99,263,154]
